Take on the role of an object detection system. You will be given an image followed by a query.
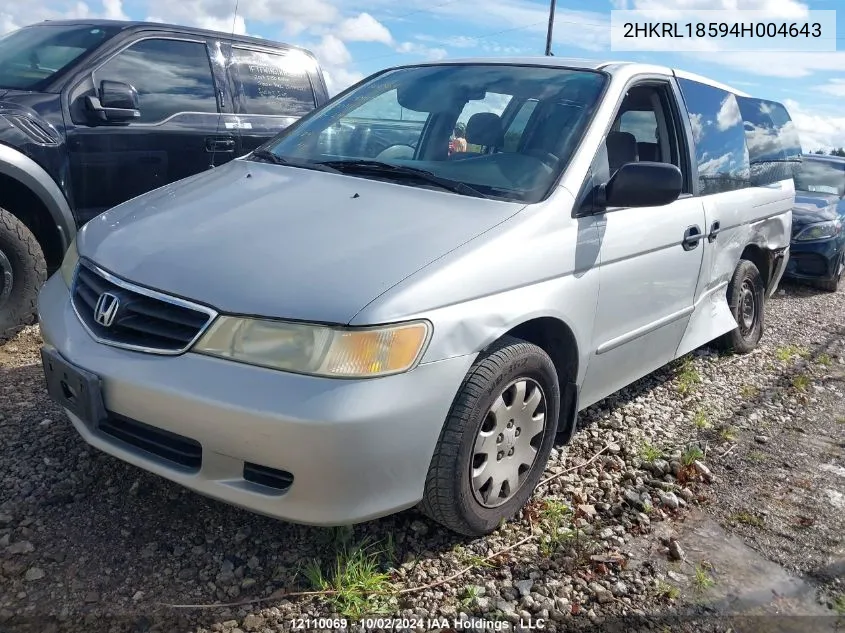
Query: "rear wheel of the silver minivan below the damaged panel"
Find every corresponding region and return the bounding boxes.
[717,259,766,354]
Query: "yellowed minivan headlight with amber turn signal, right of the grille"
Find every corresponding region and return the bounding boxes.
[193,316,431,378]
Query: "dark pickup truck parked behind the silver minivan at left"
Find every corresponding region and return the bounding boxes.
[0,20,328,341]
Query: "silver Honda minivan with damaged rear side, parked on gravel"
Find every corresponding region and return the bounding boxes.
[34,58,801,535]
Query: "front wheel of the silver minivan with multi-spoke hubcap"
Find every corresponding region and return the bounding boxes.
[421,337,560,536]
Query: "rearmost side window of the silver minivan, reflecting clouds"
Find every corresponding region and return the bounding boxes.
[737,97,801,187]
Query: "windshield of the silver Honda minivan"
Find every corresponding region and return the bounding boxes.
[256,64,605,202]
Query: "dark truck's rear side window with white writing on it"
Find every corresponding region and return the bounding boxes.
[232,48,317,117]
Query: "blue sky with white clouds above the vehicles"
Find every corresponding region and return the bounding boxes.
[0,0,845,151]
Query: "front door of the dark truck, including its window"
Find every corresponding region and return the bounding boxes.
[67,34,232,223]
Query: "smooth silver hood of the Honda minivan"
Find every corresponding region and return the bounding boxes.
[78,160,524,323]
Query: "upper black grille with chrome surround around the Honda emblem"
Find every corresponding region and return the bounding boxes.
[73,261,216,354]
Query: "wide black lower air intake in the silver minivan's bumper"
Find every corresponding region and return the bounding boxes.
[98,412,202,471]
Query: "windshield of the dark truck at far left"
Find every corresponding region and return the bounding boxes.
[0,24,119,90]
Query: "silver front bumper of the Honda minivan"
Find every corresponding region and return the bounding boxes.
[38,275,474,525]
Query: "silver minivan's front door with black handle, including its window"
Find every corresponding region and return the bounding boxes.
[581,82,706,406]
